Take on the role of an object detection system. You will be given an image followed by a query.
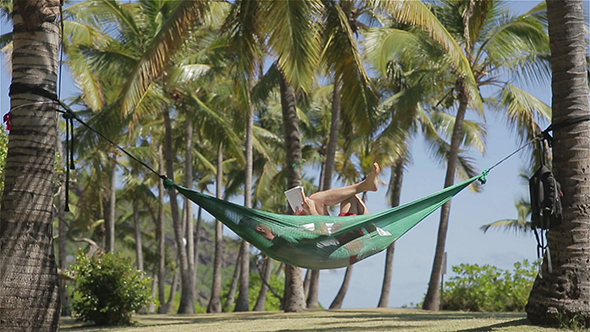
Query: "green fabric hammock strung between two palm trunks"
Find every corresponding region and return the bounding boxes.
[165,170,487,270]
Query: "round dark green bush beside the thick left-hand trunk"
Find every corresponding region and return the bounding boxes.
[72,252,152,325]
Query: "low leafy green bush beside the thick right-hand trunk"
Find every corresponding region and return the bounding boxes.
[442,260,538,311]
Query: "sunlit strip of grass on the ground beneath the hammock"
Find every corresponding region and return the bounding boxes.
[61,309,580,332]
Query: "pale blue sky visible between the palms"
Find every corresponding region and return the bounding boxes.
[0,1,588,308]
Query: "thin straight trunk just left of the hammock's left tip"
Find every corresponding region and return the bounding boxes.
[156,146,168,314]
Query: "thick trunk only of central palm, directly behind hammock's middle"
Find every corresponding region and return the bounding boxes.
[280,72,305,312]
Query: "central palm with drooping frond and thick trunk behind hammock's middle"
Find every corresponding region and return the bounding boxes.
[261,0,321,312]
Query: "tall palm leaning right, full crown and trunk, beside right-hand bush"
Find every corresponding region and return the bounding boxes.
[376,1,548,310]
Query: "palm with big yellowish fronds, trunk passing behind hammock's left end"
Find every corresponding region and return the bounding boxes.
[68,1,235,312]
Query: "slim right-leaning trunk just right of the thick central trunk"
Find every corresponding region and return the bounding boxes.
[307,81,342,308]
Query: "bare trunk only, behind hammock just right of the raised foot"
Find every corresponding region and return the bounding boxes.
[377,156,405,308]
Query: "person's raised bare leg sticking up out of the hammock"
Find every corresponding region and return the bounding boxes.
[309,163,381,214]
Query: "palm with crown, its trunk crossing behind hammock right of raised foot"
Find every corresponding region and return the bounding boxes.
[364,16,494,307]
